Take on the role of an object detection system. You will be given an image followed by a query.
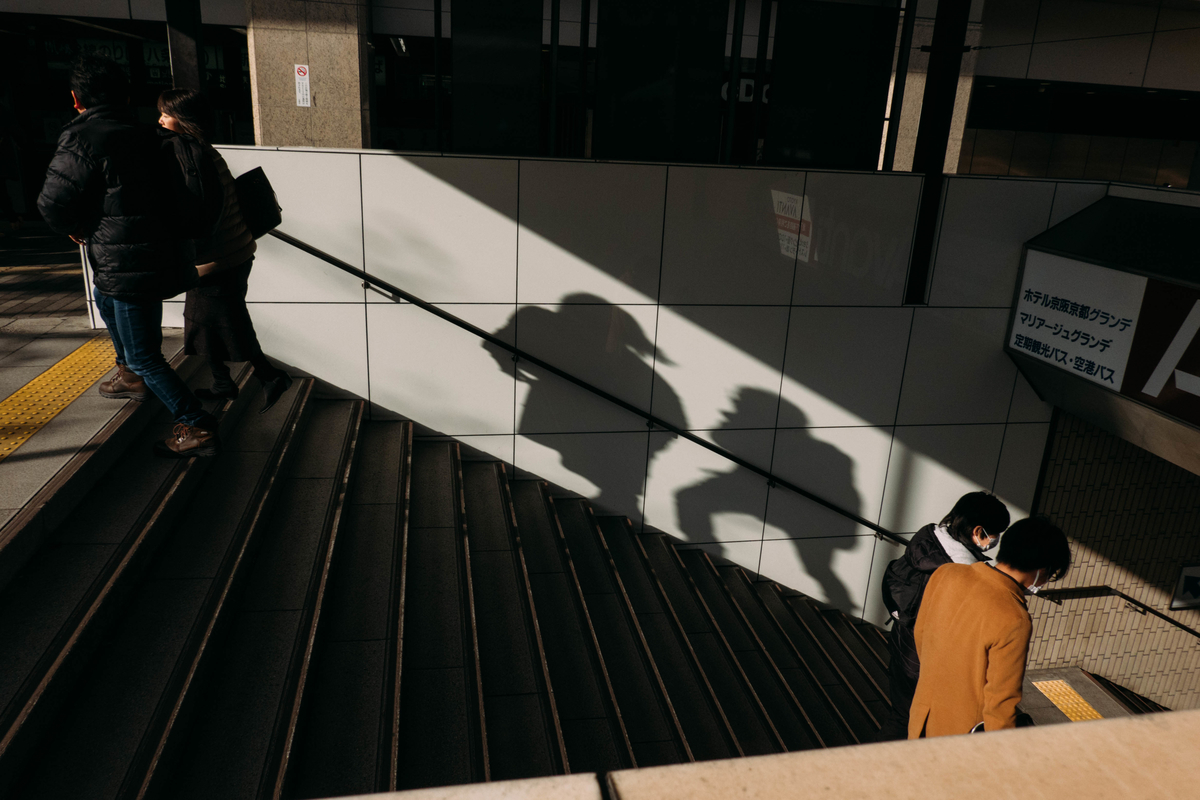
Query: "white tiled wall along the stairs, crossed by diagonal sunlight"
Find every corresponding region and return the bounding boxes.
[100,148,1142,619]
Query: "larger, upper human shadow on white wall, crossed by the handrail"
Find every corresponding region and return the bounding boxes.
[484,294,683,524]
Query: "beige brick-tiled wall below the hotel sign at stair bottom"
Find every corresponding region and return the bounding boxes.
[1030,411,1200,709]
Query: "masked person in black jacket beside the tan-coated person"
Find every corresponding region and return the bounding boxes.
[878,492,1009,741]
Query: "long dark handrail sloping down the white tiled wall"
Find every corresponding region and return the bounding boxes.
[262,230,908,546]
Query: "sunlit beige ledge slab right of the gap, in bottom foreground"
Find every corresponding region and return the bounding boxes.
[608,711,1200,800]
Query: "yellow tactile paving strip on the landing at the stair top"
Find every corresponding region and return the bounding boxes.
[0,336,116,461]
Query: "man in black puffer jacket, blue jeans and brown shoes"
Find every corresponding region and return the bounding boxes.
[37,54,220,458]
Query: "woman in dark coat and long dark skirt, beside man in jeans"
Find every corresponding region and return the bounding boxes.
[158,89,292,414]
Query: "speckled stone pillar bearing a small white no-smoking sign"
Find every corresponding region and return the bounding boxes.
[246,0,370,148]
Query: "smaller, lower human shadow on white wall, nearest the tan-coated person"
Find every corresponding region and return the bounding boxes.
[676,387,859,609]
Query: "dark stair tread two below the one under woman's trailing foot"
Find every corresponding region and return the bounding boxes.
[289,422,413,798]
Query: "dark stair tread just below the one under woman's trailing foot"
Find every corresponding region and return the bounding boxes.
[163,401,362,799]
